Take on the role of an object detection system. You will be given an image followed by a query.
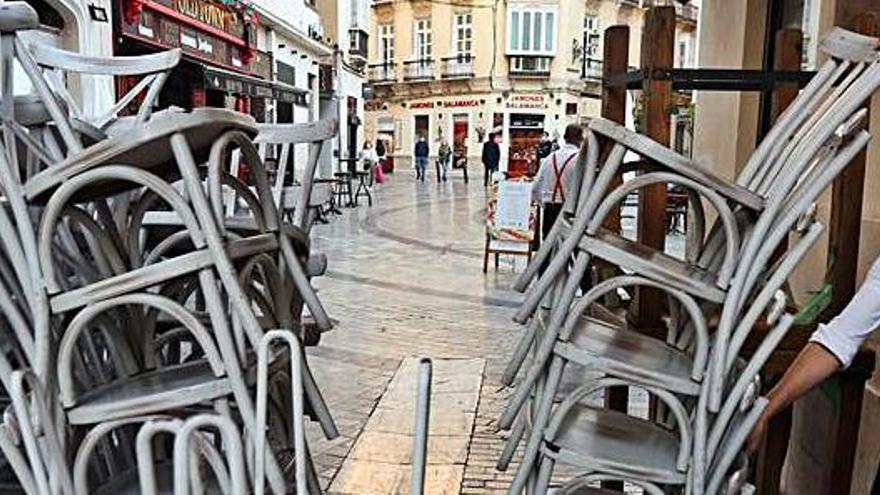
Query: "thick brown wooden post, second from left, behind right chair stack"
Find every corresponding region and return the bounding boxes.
[637,7,675,337]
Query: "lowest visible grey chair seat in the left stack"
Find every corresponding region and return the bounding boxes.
[67,360,232,425]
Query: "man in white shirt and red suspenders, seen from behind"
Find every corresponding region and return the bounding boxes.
[532,124,584,240]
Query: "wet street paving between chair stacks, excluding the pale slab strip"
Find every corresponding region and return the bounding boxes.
[309,171,520,493]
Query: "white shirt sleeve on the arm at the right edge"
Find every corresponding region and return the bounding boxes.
[810,258,880,367]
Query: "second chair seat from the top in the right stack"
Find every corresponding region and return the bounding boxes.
[578,229,727,304]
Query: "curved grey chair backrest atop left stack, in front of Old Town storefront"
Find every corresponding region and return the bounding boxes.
[28,43,181,128]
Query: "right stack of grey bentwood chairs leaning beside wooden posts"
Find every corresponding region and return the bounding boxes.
[499,28,880,495]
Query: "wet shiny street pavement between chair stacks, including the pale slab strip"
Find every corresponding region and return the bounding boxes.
[309,172,523,494]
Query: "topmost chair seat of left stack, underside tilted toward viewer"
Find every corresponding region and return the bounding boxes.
[25,108,256,202]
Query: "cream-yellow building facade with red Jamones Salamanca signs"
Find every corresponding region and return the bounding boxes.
[366,0,697,174]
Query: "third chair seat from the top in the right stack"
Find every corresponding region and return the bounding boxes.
[557,317,700,395]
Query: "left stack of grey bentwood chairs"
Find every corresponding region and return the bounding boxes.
[0,2,338,495]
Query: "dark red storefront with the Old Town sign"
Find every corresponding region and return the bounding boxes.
[114,0,307,122]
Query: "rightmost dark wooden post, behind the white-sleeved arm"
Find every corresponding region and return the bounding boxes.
[822,9,880,493]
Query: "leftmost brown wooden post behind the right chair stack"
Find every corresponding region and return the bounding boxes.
[602,25,629,491]
